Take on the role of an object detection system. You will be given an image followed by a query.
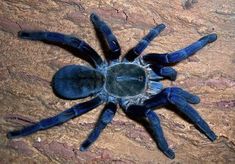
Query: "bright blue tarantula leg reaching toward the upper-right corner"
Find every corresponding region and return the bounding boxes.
[143,34,217,64]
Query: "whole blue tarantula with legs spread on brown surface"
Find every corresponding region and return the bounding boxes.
[7,13,217,159]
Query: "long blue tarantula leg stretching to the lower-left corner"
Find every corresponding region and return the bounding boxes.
[7,97,102,139]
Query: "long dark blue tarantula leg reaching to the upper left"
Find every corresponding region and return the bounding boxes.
[18,31,103,67]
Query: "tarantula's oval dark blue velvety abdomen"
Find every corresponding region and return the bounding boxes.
[52,65,104,99]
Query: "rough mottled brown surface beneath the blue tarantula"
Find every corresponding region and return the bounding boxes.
[0,0,235,163]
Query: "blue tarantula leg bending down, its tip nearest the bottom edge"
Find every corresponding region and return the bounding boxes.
[126,105,175,159]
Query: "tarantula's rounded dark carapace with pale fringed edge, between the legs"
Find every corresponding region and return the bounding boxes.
[105,63,146,97]
